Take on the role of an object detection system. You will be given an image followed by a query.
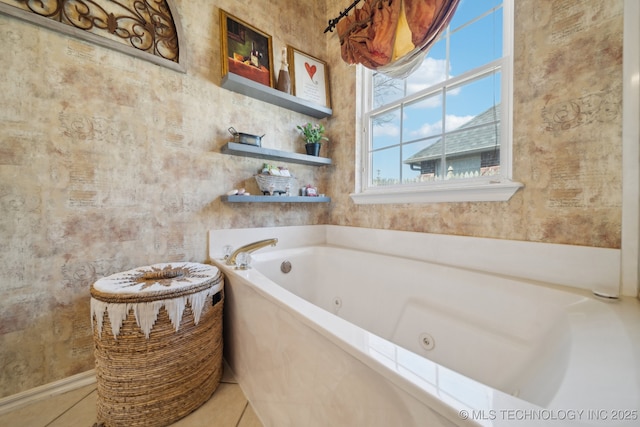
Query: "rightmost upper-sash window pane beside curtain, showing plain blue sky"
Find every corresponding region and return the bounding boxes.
[451,9,502,76]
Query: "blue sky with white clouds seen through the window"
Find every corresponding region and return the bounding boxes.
[373,0,502,184]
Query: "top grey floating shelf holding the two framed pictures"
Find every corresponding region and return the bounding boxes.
[221,73,333,119]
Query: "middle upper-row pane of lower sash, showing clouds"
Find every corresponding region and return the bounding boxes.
[402,94,442,141]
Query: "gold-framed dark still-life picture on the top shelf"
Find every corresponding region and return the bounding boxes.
[220,9,274,87]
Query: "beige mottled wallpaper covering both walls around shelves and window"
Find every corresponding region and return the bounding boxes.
[0,0,622,397]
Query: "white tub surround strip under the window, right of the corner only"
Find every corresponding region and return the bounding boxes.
[326,225,620,296]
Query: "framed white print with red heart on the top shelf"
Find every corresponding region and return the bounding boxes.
[287,46,331,108]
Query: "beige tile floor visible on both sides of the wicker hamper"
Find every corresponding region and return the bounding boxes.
[0,364,262,427]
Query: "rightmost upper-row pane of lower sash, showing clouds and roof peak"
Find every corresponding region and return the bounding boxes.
[445,72,500,132]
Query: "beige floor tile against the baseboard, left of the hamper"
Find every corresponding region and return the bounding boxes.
[0,384,96,427]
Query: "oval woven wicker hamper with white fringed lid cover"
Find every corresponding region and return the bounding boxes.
[91,263,224,427]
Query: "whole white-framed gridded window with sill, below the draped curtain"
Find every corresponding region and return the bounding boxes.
[351,0,521,203]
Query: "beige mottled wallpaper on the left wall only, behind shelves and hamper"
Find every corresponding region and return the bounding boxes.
[0,0,328,397]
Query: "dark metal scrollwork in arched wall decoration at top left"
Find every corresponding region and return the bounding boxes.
[14,0,179,63]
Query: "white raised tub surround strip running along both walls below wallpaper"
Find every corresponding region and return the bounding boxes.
[208,225,624,296]
